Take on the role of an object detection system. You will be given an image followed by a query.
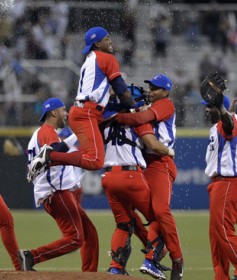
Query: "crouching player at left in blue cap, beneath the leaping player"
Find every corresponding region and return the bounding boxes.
[20,98,99,271]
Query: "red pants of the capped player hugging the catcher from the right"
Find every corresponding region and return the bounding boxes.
[144,156,182,260]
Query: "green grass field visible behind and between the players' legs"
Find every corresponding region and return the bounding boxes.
[0,210,235,280]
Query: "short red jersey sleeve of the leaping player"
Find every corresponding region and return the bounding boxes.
[95,51,122,81]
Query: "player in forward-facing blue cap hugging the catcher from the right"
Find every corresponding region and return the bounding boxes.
[115,74,183,280]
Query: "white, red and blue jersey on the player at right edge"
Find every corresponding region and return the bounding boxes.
[205,115,237,177]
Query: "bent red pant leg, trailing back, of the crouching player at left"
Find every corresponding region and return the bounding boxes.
[31,190,85,264]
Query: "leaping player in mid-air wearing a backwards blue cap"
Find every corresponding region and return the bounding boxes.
[26,27,139,179]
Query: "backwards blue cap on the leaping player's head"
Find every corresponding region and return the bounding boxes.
[82,27,109,54]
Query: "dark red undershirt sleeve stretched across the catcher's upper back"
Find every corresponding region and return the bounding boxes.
[115,110,155,126]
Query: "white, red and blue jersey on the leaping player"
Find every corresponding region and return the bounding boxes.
[76,51,121,107]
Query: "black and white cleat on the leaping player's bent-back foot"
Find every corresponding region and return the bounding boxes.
[27,144,53,183]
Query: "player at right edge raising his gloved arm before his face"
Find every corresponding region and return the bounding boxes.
[201,93,237,280]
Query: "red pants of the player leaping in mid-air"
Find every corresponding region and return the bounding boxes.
[50,102,104,170]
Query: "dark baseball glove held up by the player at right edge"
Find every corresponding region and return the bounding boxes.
[200,72,226,108]
